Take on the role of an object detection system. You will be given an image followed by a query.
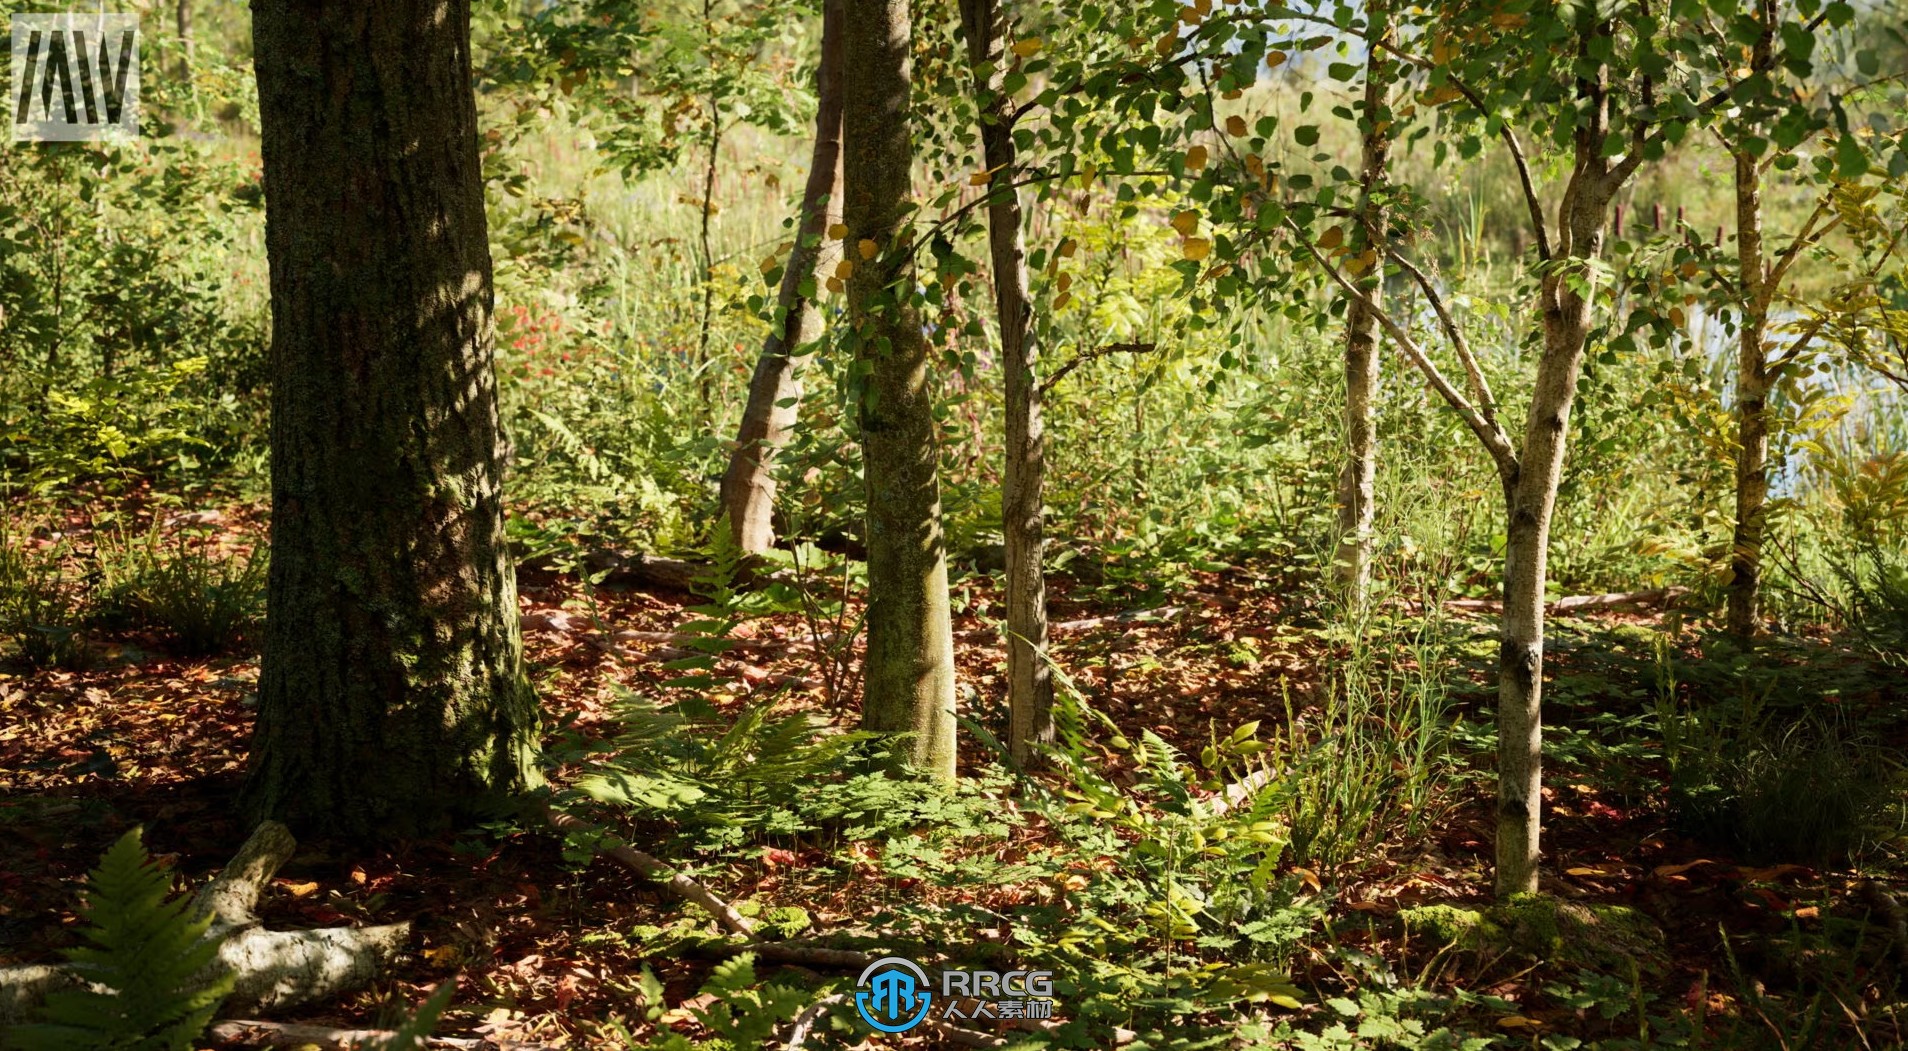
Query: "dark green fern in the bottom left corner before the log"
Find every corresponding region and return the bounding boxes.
[8,828,233,1051]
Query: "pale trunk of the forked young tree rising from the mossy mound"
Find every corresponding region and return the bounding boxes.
[1496,162,1616,898]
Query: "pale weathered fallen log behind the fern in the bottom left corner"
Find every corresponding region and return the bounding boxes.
[0,822,410,1024]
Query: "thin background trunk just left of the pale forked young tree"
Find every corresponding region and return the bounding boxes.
[1336,14,1391,605]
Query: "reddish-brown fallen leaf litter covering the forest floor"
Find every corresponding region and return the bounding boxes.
[0,511,1908,1047]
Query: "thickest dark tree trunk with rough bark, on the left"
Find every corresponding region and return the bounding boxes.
[244,0,536,835]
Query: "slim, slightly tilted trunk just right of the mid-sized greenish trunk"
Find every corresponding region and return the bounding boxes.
[960,0,1053,765]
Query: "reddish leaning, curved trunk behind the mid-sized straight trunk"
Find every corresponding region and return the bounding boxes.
[721,0,843,553]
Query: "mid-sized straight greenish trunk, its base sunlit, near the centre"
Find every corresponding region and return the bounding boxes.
[841,0,954,778]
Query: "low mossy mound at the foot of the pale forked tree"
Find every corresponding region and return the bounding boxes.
[1399,895,1668,971]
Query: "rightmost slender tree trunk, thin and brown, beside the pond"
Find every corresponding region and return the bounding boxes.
[1727,151,1769,643]
